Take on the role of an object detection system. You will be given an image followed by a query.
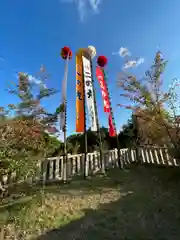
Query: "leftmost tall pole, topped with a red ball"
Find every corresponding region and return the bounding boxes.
[59,47,72,182]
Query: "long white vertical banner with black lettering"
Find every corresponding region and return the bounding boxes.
[82,56,97,132]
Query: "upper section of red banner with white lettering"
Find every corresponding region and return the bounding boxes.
[96,66,110,113]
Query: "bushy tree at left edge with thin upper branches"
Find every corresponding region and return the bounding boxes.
[0,67,57,195]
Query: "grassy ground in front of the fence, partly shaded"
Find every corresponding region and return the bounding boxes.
[0,166,180,240]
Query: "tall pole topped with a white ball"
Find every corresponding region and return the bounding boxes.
[88,46,105,174]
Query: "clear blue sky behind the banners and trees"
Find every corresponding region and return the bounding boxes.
[0,0,180,137]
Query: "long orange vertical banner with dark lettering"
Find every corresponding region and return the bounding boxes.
[76,52,85,133]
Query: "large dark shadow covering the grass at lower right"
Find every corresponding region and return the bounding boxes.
[34,166,180,240]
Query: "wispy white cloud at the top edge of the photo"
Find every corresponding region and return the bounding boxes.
[60,0,102,21]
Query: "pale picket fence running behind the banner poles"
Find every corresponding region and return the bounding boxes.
[3,147,179,184]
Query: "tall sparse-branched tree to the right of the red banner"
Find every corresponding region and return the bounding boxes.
[118,52,171,144]
